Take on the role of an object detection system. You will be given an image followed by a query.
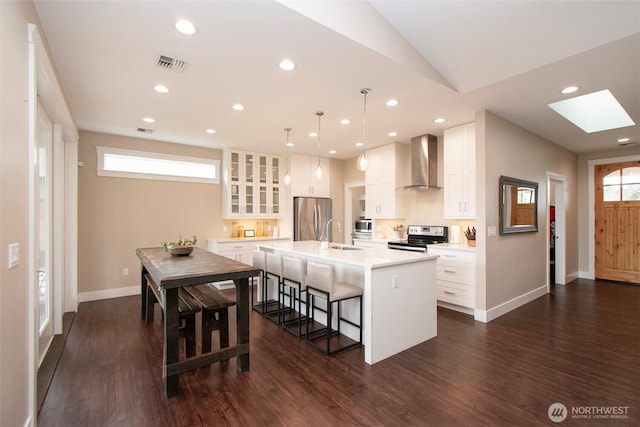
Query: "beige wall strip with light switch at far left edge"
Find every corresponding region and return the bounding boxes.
[0,1,39,426]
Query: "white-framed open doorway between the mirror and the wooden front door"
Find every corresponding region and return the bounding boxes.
[547,172,567,289]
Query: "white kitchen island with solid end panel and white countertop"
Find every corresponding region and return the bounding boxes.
[258,241,438,364]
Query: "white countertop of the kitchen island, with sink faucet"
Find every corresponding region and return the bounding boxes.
[258,240,438,268]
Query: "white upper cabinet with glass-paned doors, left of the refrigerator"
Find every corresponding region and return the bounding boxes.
[222,150,282,218]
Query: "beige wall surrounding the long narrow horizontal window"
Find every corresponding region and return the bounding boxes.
[78,132,222,301]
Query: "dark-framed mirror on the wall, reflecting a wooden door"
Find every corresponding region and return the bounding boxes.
[500,176,538,235]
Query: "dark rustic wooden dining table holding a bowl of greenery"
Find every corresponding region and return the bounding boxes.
[136,247,260,397]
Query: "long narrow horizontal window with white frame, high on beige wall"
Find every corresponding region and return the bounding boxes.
[96,146,220,184]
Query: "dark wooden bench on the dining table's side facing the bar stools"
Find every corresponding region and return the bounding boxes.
[185,285,236,354]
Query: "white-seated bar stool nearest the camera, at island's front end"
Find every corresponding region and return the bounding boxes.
[306,261,362,355]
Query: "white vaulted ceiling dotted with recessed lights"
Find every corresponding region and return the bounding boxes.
[35,0,640,158]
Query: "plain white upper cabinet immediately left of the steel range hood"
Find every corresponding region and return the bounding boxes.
[365,143,408,218]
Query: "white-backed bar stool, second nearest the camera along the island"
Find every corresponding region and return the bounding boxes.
[280,256,307,338]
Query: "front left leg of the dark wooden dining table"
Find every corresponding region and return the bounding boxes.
[162,288,180,397]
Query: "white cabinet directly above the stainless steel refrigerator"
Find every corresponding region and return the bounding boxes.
[291,154,330,197]
